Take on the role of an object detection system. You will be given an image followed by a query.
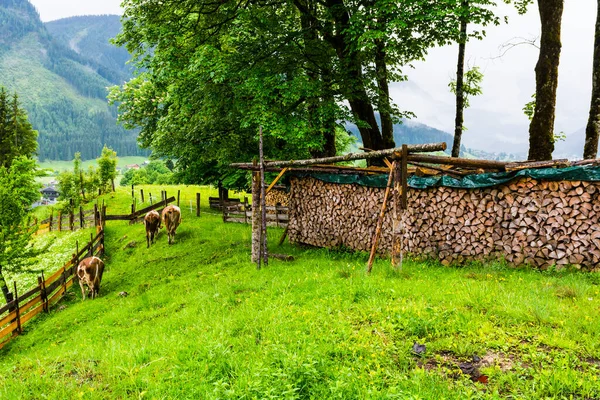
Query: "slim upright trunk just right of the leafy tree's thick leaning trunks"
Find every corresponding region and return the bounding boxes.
[375,40,396,149]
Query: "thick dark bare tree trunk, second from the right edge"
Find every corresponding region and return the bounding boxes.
[528,0,564,161]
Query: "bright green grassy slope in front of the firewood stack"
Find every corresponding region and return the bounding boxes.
[0,186,600,399]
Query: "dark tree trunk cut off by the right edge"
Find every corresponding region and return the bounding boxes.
[583,0,600,159]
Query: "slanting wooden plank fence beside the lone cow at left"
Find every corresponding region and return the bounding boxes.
[0,227,104,348]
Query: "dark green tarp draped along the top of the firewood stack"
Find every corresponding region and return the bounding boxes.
[294,166,600,189]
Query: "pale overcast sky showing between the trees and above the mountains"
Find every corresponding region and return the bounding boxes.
[31,0,596,152]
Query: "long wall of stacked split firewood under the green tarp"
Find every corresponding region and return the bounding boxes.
[288,178,600,268]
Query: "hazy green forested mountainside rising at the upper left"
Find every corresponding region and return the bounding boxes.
[0,0,148,160]
